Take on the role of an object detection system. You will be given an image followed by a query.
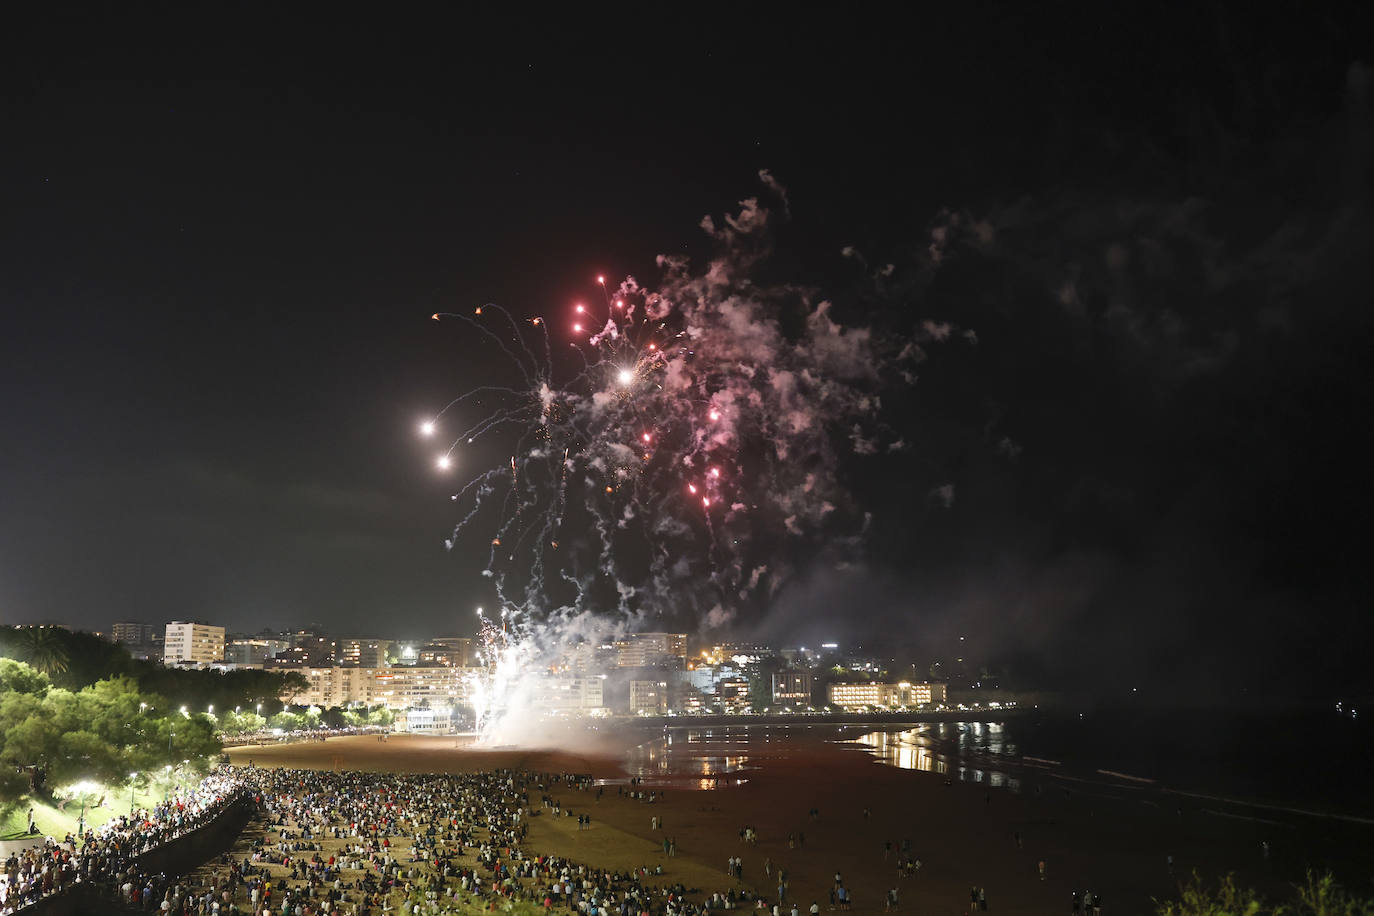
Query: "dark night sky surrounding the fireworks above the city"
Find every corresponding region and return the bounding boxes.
[0,4,1374,702]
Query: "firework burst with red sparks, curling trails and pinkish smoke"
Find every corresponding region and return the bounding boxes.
[422,173,934,747]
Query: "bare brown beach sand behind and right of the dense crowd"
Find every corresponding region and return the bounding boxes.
[228,736,1374,915]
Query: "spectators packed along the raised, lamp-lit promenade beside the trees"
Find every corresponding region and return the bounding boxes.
[0,769,249,916]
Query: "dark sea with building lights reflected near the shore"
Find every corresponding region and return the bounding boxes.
[625,709,1374,824]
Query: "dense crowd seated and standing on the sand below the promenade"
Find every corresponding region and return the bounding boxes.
[166,768,802,916]
